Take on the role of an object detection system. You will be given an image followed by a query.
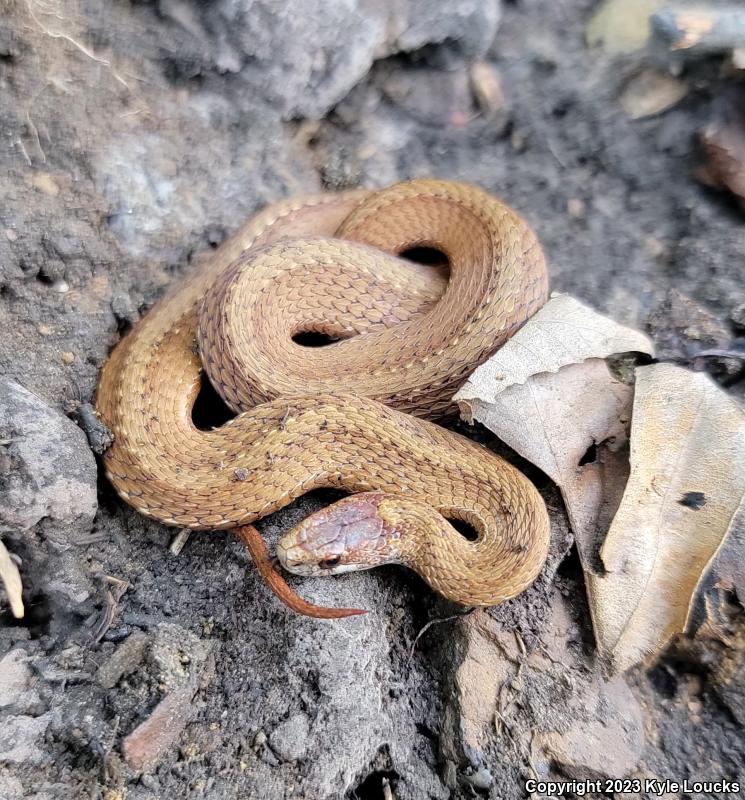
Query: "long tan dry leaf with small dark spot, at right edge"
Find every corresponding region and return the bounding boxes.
[588,364,745,669]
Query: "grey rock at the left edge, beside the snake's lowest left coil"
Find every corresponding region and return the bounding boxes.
[0,380,97,533]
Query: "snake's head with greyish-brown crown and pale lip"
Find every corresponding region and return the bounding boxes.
[277,492,401,576]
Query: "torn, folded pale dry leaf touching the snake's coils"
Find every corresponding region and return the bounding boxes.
[455,295,653,571]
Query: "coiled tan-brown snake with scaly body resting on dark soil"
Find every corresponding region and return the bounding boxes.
[96,179,550,616]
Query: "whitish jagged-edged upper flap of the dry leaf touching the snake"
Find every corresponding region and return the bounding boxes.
[454,294,653,416]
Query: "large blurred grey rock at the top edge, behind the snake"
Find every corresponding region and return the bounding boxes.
[150,0,501,119]
